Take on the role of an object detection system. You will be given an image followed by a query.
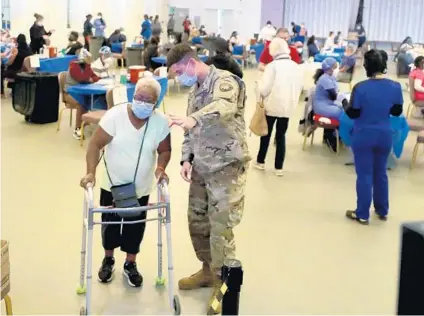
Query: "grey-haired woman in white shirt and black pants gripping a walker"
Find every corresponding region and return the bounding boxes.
[80,78,171,287]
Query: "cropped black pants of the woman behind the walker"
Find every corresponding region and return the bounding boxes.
[100,189,149,254]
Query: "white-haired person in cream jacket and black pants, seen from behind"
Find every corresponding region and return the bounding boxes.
[255,37,303,176]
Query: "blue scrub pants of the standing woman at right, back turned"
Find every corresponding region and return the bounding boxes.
[352,128,392,220]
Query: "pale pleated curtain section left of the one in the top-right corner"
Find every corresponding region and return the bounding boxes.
[284,0,356,37]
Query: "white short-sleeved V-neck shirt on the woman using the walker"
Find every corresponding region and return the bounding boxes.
[99,104,170,198]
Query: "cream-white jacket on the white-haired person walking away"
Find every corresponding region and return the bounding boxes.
[258,55,303,118]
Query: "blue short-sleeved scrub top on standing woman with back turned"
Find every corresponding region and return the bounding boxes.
[350,79,403,132]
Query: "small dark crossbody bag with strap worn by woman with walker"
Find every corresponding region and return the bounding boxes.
[103,121,149,217]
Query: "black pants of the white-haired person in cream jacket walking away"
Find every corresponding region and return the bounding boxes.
[256,115,289,170]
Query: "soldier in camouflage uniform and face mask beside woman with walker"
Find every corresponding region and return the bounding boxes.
[167,44,250,312]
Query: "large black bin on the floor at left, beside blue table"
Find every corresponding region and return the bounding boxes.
[12,72,59,124]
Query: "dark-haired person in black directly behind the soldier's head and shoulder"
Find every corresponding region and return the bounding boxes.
[206,38,243,78]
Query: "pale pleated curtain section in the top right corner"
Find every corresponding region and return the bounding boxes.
[364,0,424,43]
